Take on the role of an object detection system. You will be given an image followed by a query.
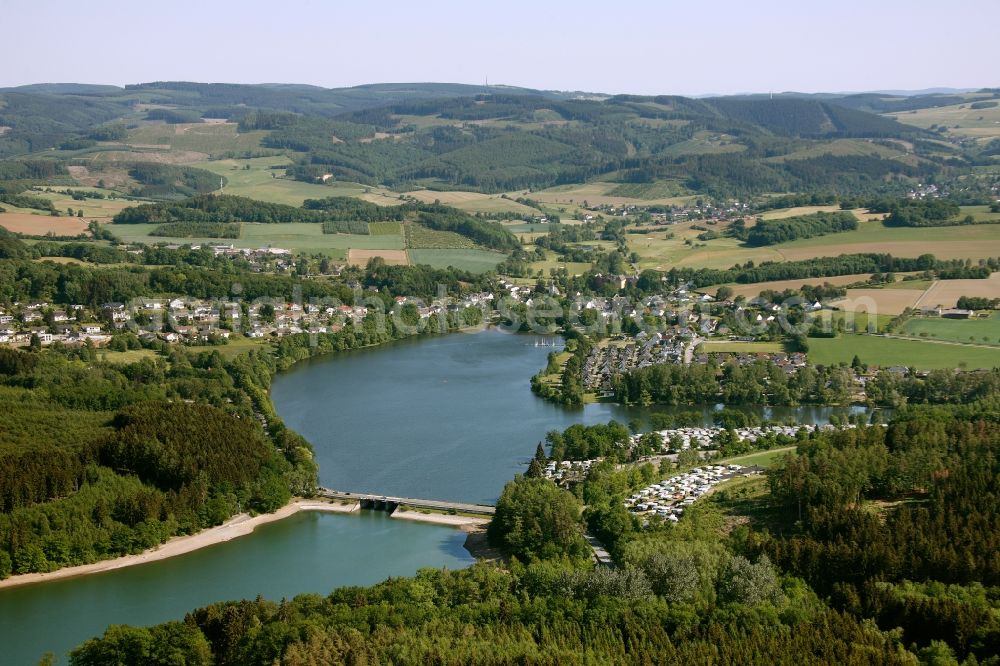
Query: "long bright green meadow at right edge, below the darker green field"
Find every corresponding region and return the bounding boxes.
[809,334,1000,370]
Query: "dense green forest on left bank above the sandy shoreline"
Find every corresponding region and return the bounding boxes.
[0,348,315,577]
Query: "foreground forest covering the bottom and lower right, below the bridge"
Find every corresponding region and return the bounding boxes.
[72,396,1000,666]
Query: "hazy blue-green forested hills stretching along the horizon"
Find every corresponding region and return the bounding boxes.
[0,82,981,197]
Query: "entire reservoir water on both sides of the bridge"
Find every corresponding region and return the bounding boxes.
[0,330,868,666]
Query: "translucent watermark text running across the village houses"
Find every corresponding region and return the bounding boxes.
[111,283,878,344]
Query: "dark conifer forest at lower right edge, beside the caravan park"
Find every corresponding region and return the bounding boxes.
[746,402,1000,661]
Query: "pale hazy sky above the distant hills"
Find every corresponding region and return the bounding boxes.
[0,0,1000,94]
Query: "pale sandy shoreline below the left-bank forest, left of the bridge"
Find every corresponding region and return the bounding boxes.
[0,500,360,589]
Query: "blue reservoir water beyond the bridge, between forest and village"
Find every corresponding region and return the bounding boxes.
[271,329,864,503]
